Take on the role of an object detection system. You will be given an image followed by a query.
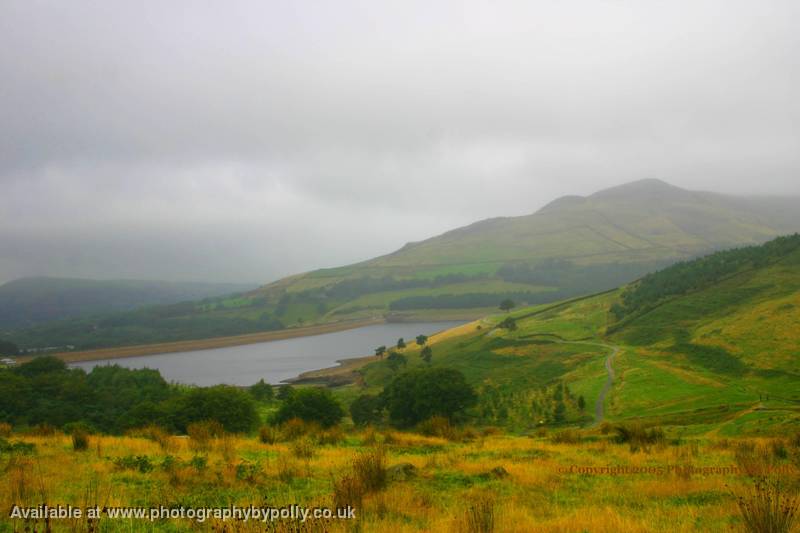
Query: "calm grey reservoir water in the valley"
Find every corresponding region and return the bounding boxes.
[73,322,463,386]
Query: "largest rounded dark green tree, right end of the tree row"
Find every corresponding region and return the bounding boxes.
[382,368,477,427]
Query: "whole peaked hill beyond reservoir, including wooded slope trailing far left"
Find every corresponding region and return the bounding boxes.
[8,180,800,348]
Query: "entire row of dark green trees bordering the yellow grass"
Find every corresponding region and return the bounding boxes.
[0,357,477,434]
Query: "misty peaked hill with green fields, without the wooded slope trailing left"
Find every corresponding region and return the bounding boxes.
[255,179,800,320]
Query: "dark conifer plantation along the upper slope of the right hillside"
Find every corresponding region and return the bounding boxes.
[611,234,800,319]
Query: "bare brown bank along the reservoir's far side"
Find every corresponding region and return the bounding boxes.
[16,318,386,364]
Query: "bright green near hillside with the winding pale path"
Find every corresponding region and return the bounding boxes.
[348,235,800,435]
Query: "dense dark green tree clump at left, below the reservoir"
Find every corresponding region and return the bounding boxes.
[0,357,259,433]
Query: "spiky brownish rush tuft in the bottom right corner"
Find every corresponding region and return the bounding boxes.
[736,478,800,533]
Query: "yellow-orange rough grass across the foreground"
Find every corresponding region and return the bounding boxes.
[0,424,800,533]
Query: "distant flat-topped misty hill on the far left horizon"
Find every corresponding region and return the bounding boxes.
[0,277,253,328]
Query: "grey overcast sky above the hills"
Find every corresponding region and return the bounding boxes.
[0,0,800,282]
